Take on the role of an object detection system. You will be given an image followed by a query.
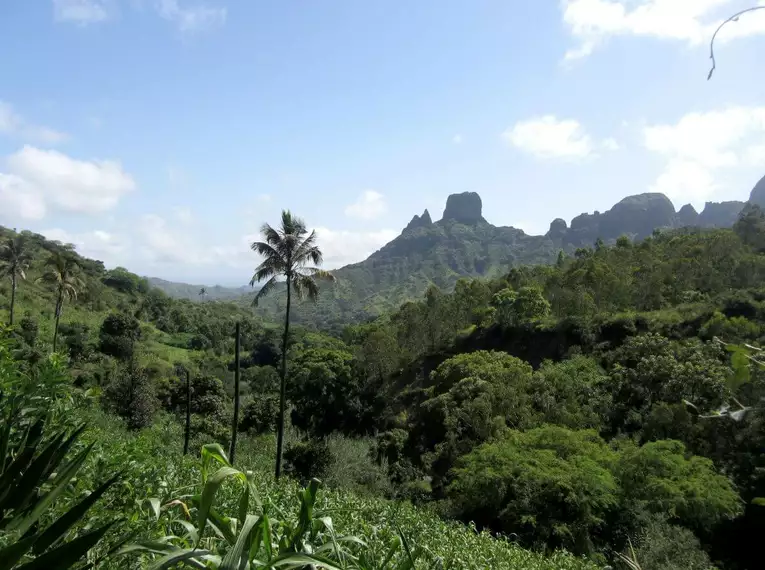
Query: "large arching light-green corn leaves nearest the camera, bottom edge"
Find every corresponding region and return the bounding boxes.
[120,444,422,570]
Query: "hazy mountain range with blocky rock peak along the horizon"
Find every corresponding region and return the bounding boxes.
[152,174,765,326]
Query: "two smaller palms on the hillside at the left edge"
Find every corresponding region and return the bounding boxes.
[0,234,82,352]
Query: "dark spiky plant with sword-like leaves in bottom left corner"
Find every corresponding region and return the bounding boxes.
[0,394,118,570]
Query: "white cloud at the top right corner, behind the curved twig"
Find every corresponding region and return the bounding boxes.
[562,0,765,60]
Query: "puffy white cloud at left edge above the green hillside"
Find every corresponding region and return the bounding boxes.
[0,145,135,219]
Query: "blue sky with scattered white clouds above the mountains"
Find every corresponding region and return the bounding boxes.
[0,0,765,285]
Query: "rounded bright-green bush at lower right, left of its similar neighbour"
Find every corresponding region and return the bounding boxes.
[448,426,619,554]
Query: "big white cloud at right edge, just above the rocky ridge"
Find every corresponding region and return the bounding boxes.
[643,107,765,204]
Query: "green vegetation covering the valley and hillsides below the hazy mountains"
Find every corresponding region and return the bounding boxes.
[0,206,765,570]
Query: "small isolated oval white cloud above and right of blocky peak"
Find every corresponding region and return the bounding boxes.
[502,115,594,159]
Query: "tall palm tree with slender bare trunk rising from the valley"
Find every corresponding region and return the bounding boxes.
[250,210,335,479]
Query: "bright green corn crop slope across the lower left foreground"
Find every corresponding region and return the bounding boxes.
[0,330,594,570]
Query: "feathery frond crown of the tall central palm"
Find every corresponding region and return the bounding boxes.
[250,210,335,306]
